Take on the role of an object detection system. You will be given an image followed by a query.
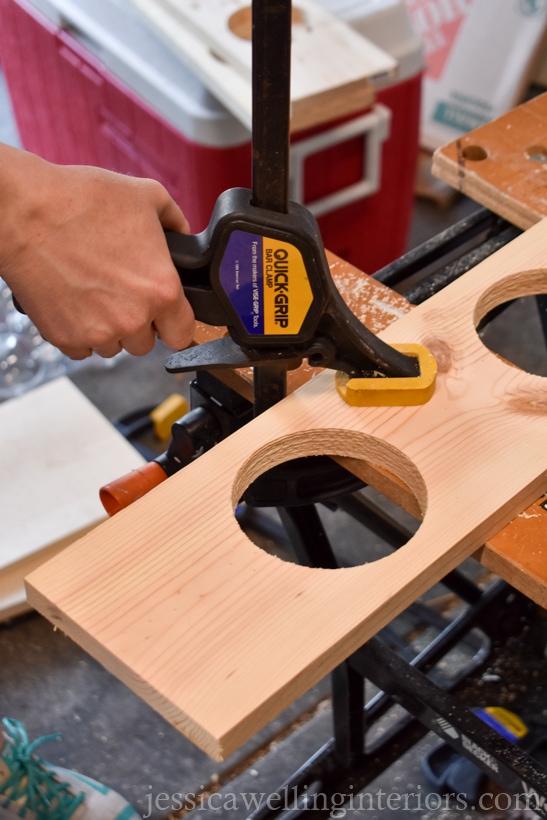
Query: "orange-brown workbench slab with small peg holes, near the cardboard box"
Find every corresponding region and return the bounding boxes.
[432,93,547,230]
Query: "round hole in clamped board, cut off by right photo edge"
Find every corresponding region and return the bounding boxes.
[475,270,547,376]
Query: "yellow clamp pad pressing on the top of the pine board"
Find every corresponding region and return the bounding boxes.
[335,344,437,407]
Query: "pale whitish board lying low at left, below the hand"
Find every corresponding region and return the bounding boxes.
[0,377,143,619]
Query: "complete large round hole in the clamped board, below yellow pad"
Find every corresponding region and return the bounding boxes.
[234,430,427,569]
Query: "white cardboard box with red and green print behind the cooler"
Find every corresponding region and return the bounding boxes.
[406,0,547,150]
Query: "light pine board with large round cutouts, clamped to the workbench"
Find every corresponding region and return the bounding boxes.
[27,223,547,758]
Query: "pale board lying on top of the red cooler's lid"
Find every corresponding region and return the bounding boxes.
[126,0,397,132]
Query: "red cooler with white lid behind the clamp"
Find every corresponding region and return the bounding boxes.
[0,0,422,273]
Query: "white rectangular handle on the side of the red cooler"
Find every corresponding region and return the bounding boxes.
[289,103,391,216]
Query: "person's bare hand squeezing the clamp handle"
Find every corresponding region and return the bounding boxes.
[0,146,194,359]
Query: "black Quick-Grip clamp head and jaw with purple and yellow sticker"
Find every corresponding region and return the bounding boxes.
[166,188,431,404]
